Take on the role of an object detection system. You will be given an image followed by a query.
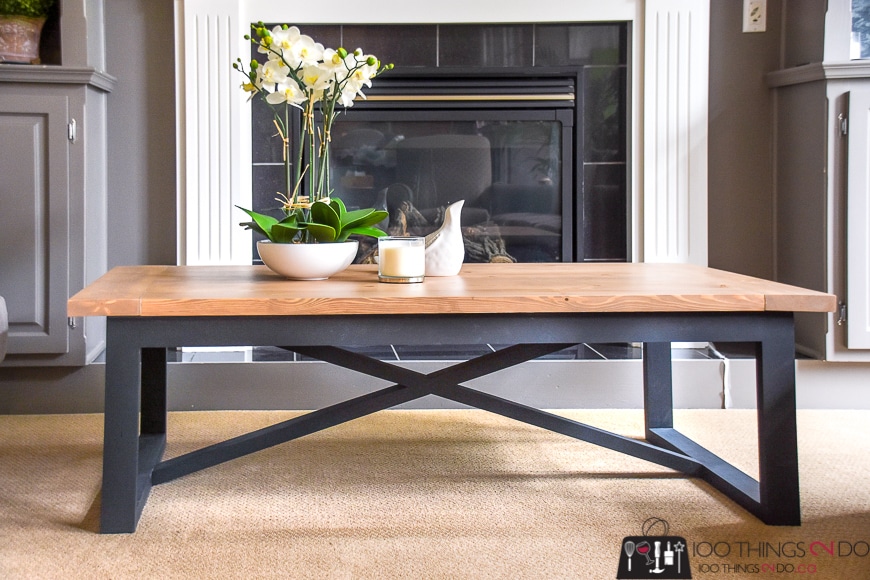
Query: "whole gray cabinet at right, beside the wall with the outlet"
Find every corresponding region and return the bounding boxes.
[767,0,870,362]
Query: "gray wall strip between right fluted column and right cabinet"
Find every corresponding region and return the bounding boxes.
[708,0,782,278]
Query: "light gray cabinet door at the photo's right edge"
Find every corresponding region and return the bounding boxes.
[846,91,870,348]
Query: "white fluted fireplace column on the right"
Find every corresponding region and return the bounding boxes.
[643,0,710,266]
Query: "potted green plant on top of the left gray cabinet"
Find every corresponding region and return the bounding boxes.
[0,0,56,64]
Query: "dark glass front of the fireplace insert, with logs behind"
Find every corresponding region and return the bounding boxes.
[330,110,572,262]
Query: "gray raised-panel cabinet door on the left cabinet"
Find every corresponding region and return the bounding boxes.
[0,91,69,354]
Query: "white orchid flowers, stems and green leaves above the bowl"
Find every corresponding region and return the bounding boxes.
[233,22,393,243]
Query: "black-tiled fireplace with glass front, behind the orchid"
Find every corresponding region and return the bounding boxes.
[252,23,631,262]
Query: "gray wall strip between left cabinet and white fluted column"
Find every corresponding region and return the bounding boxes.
[105,0,176,268]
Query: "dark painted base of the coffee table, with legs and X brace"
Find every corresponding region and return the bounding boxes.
[100,313,800,533]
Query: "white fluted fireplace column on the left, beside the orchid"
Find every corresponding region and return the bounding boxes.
[176,0,251,265]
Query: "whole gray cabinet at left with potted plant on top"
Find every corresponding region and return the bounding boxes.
[0,0,115,366]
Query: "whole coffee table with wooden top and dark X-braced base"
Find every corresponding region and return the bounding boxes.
[68,263,836,533]
